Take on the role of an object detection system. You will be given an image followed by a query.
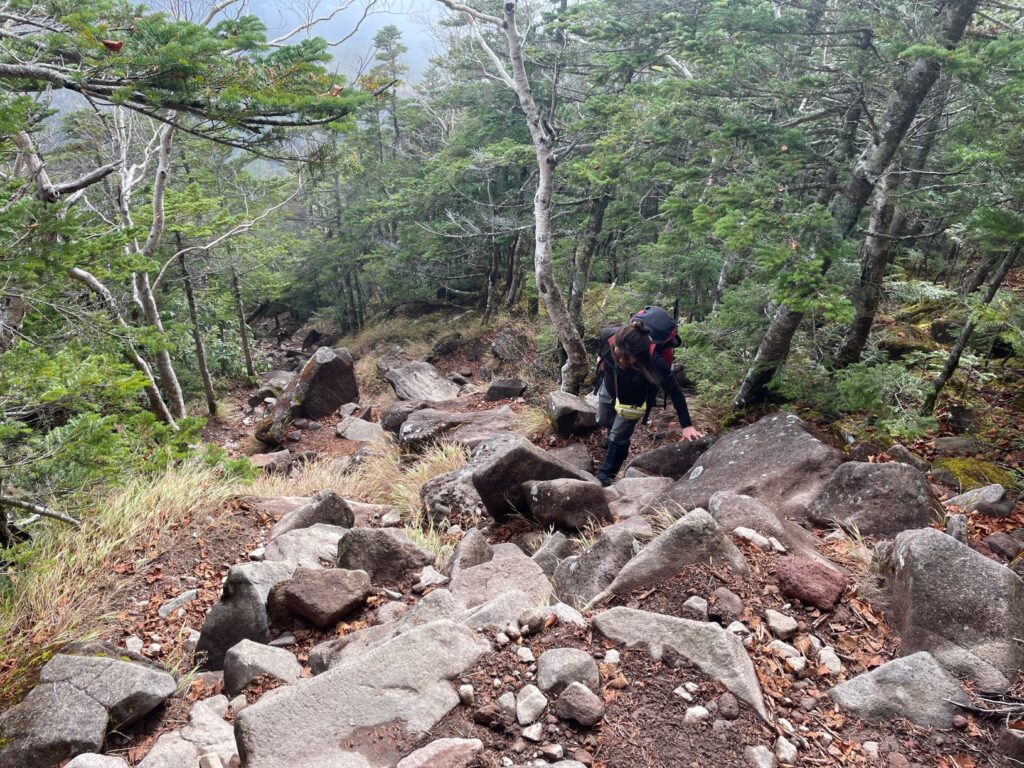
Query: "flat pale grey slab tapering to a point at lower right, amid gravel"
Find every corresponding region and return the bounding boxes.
[594,607,768,720]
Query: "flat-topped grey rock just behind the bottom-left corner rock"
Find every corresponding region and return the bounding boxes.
[39,653,177,728]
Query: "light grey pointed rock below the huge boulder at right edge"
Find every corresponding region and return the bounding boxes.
[828,651,968,728]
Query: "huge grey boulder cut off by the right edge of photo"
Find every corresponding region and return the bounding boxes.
[876,528,1024,690]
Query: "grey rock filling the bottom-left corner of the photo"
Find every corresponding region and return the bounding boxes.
[0,683,108,768]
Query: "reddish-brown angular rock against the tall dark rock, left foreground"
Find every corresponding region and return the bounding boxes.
[278,568,373,628]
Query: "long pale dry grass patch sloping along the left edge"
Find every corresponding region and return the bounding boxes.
[0,462,243,709]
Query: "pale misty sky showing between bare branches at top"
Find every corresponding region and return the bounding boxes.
[251,0,443,82]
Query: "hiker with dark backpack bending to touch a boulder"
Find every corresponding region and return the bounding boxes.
[595,307,703,485]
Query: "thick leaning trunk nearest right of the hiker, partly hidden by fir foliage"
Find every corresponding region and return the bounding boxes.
[732,0,978,410]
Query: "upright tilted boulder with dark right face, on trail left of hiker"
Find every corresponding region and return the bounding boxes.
[256,347,359,445]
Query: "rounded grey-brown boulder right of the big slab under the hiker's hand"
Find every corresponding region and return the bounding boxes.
[806,462,942,536]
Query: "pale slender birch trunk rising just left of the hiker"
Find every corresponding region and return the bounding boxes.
[502,0,590,394]
